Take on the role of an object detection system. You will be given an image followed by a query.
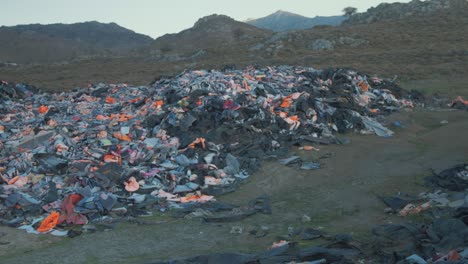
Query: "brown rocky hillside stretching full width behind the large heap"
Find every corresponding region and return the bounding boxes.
[0,0,468,89]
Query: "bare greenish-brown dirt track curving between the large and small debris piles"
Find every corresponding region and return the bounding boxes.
[0,110,468,263]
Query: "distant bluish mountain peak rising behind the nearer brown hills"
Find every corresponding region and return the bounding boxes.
[246,10,346,32]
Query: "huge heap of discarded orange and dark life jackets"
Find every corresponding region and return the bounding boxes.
[0,66,414,234]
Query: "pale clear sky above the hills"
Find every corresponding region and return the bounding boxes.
[0,0,410,38]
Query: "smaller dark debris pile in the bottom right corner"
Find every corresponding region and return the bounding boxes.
[373,164,468,263]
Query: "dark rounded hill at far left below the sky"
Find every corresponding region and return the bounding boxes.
[0,21,153,63]
